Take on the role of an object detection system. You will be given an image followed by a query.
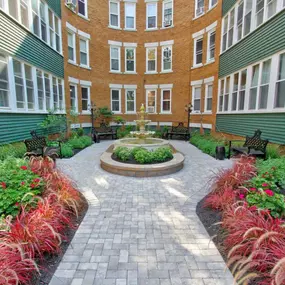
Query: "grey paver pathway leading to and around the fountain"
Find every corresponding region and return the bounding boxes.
[50,141,233,285]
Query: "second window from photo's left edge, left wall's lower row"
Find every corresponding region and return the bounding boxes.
[13,59,25,109]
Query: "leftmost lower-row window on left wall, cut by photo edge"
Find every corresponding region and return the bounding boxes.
[0,54,9,108]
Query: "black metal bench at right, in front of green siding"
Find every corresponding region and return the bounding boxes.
[228,130,269,159]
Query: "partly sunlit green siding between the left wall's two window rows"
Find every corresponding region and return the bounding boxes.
[0,10,64,78]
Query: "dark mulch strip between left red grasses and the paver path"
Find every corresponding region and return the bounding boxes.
[30,193,88,285]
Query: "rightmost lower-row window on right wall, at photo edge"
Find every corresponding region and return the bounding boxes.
[274,53,285,108]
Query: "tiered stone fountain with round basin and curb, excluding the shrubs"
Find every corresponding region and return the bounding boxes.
[101,104,184,177]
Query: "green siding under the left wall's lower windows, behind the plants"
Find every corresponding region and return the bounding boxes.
[0,113,66,145]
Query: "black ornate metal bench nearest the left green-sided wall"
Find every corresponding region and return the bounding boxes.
[24,131,62,160]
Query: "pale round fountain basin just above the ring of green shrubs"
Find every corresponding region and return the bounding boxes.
[114,138,170,151]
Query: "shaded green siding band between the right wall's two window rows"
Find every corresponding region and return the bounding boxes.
[219,11,285,77]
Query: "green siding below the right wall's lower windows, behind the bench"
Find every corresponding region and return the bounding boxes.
[216,113,285,144]
